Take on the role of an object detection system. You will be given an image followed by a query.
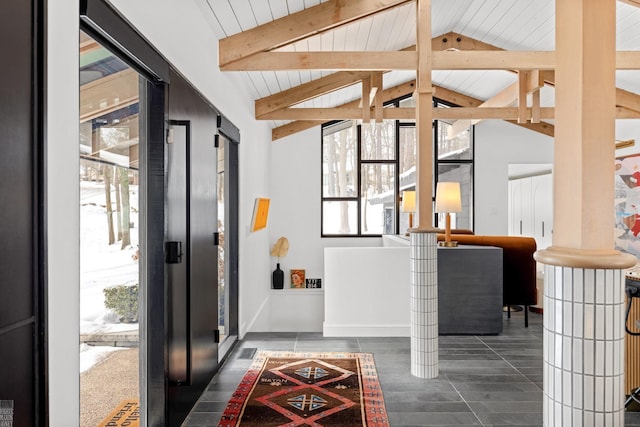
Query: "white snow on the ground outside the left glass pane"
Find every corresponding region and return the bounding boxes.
[80,181,139,371]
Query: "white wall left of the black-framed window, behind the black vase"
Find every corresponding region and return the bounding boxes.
[258,126,381,332]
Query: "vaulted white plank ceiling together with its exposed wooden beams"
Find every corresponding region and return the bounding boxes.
[206,0,640,140]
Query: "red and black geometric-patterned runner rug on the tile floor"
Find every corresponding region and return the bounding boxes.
[218,351,389,427]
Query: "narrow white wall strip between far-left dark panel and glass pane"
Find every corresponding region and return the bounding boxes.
[46,0,80,427]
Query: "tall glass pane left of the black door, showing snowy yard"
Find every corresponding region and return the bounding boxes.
[79,32,145,427]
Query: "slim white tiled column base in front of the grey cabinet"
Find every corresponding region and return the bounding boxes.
[410,229,438,378]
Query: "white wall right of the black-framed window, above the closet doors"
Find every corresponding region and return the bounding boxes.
[474,120,553,235]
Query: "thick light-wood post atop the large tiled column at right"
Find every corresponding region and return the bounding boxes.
[552,0,625,251]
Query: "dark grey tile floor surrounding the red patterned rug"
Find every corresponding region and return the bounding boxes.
[183,312,640,427]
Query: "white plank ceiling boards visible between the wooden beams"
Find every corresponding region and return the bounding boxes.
[201,0,640,135]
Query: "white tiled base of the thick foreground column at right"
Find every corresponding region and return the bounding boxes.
[543,265,625,427]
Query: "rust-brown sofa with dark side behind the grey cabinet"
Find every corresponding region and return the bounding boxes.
[437,231,538,327]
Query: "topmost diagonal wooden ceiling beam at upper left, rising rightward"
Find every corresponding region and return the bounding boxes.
[218,0,411,68]
